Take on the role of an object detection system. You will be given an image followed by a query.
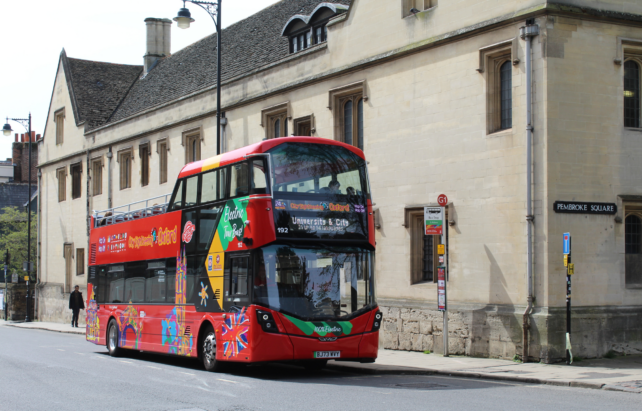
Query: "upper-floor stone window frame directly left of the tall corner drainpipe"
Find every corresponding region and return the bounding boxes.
[476,37,520,135]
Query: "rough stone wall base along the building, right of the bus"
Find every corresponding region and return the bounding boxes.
[381,302,642,363]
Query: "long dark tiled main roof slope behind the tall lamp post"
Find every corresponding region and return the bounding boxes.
[104,0,351,127]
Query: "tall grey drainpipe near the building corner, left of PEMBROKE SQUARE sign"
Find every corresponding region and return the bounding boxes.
[519,19,539,362]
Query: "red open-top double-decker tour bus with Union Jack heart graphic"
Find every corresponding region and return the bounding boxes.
[87,137,381,371]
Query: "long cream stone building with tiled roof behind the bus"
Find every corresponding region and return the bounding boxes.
[39,0,642,362]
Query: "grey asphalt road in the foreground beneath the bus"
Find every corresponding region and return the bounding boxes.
[0,326,642,411]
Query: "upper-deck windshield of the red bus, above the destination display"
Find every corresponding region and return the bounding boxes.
[269,143,369,196]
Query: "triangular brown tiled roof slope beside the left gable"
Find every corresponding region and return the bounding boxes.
[65,56,143,128]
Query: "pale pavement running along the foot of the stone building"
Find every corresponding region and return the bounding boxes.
[0,320,642,393]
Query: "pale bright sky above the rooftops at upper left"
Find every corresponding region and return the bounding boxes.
[0,0,277,160]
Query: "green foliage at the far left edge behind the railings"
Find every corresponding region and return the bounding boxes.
[0,207,38,278]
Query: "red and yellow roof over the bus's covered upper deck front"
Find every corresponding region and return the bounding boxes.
[178,137,365,178]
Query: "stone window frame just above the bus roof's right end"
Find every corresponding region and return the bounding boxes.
[328,80,369,150]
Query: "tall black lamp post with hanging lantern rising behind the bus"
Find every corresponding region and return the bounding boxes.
[174,0,223,155]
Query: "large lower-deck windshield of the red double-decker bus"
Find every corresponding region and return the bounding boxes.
[253,245,375,321]
